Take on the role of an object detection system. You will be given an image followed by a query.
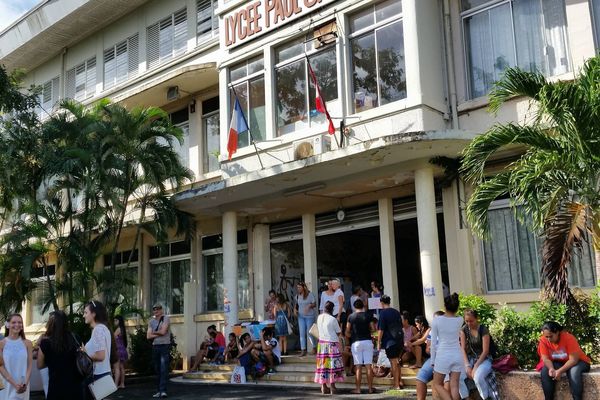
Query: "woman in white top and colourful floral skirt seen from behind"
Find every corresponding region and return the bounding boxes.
[315,301,344,394]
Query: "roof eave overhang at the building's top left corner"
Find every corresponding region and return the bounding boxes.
[0,0,148,71]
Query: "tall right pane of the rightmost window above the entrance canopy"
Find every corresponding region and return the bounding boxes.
[376,21,406,105]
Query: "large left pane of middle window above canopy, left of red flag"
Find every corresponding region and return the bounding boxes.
[276,60,307,135]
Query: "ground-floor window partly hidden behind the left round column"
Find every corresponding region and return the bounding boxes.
[202,230,251,311]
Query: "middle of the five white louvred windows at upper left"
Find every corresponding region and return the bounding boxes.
[104,33,139,90]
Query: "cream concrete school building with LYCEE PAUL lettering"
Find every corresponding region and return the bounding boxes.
[0,0,600,368]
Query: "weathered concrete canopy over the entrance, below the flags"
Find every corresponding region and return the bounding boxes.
[176,130,475,220]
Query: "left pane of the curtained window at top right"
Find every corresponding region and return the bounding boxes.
[465,5,515,97]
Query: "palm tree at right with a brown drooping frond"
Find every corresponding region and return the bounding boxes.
[461,57,600,303]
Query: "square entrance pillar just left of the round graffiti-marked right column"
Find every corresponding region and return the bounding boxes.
[378,199,400,309]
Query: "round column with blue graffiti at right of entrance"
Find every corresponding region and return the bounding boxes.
[415,167,444,318]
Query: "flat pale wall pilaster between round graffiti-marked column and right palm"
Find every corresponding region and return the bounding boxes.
[442,183,476,293]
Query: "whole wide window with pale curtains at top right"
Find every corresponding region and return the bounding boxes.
[462,0,570,98]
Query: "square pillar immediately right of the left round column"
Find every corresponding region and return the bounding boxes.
[252,224,272,321]
